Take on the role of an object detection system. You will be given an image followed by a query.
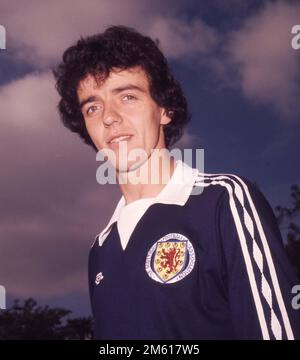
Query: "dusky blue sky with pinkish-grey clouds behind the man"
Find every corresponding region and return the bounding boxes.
[0,0,300,315]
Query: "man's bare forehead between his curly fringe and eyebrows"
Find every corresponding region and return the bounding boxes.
[77,66,149,96]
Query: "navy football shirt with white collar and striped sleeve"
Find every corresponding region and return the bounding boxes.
[89,161,300,340]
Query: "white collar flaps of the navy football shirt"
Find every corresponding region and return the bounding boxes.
[95,160,199,246]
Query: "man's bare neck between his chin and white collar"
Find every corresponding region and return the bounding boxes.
[117,152,175,205]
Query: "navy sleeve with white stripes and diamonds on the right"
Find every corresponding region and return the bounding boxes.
[217,175,300,340]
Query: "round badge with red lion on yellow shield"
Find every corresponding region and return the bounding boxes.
[145,233,195,284]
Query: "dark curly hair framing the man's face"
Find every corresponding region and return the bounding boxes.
[53,25,190,151]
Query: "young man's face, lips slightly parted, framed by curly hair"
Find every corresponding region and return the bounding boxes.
[77,67,171,171]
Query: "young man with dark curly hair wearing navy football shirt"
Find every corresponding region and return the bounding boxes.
[54,26,300,340]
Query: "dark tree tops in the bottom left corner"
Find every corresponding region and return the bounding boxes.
[0,298,92,340]
